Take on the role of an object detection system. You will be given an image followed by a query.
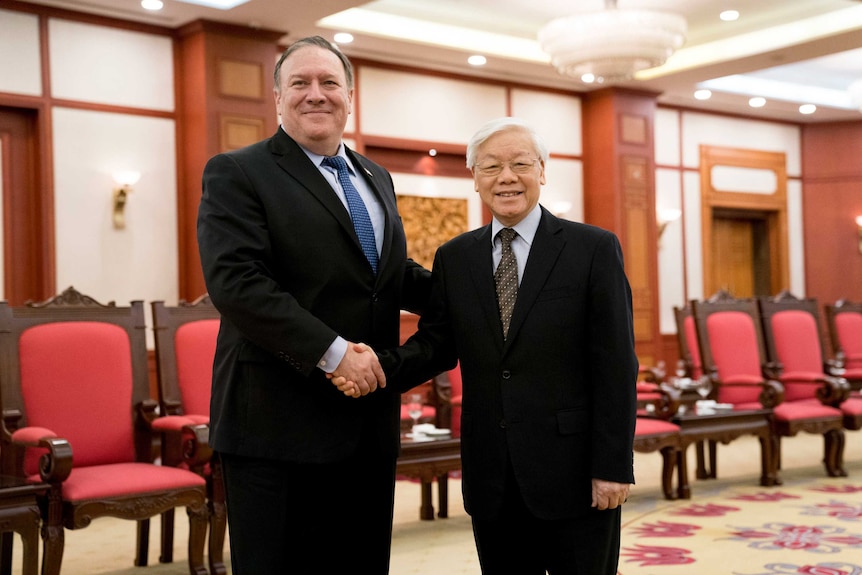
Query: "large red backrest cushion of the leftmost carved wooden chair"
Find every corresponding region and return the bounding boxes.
[19,321,135,467]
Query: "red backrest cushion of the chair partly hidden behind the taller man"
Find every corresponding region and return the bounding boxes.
[174,319,219,418]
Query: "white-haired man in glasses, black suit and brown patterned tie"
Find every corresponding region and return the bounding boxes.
[346,118,638,575]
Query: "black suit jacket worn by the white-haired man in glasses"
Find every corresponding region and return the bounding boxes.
[381,209,637,519]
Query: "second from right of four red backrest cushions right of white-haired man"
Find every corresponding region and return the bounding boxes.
[770,310,823,401]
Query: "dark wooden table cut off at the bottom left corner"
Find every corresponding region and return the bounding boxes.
[0,475,48,575]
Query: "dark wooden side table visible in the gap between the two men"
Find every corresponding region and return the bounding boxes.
[395,436,461,520]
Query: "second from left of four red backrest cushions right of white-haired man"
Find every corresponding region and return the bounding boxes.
[706,311,762,403]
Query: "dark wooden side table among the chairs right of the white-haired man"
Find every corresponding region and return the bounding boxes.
[671,409,781,499]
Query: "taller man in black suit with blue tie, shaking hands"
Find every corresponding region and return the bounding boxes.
[198,37,430,575]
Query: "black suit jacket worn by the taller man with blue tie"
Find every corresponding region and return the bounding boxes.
[198,129,430,462]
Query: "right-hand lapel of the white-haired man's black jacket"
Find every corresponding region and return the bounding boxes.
[506,208,566,350]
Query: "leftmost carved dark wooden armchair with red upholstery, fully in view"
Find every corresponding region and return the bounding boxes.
[0,288,209,575]
